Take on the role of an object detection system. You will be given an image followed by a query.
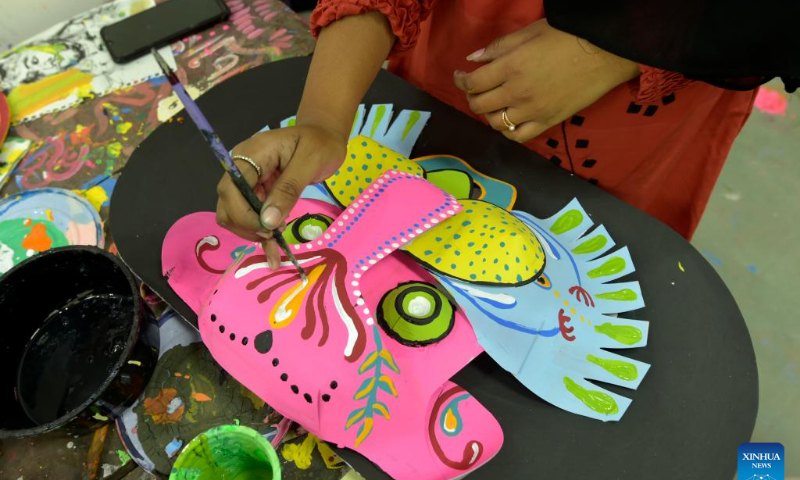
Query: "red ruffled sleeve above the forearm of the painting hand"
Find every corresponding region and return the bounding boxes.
[311,0,435,53]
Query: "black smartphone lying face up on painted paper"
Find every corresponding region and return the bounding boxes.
[100,0,231,63]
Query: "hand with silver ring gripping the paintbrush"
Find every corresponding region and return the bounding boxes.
[217,125,347,270]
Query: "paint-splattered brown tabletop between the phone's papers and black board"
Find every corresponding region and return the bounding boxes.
[0,0,314,251]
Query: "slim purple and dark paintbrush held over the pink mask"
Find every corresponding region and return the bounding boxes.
[152,48,306,281]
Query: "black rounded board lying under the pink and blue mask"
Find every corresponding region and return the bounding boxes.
[110,58,758,480]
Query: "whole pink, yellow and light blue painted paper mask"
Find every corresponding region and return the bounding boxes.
[163,105,649,479]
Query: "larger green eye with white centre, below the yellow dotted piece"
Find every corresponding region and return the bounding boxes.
[378,282,455,347]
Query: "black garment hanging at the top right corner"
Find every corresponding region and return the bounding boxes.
[544,0,800,92]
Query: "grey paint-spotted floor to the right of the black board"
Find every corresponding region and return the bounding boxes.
[692,81,800,477]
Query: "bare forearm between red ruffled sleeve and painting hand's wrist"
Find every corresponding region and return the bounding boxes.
[297,12,395,138]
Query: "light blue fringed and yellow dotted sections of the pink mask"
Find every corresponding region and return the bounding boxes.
[294,106,649,421]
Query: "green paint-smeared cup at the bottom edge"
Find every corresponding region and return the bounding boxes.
[169,425,281,480]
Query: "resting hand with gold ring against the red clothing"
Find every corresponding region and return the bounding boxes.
[454,19,639,142]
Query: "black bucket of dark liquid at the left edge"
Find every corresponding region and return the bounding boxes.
[0,247,159,439]
